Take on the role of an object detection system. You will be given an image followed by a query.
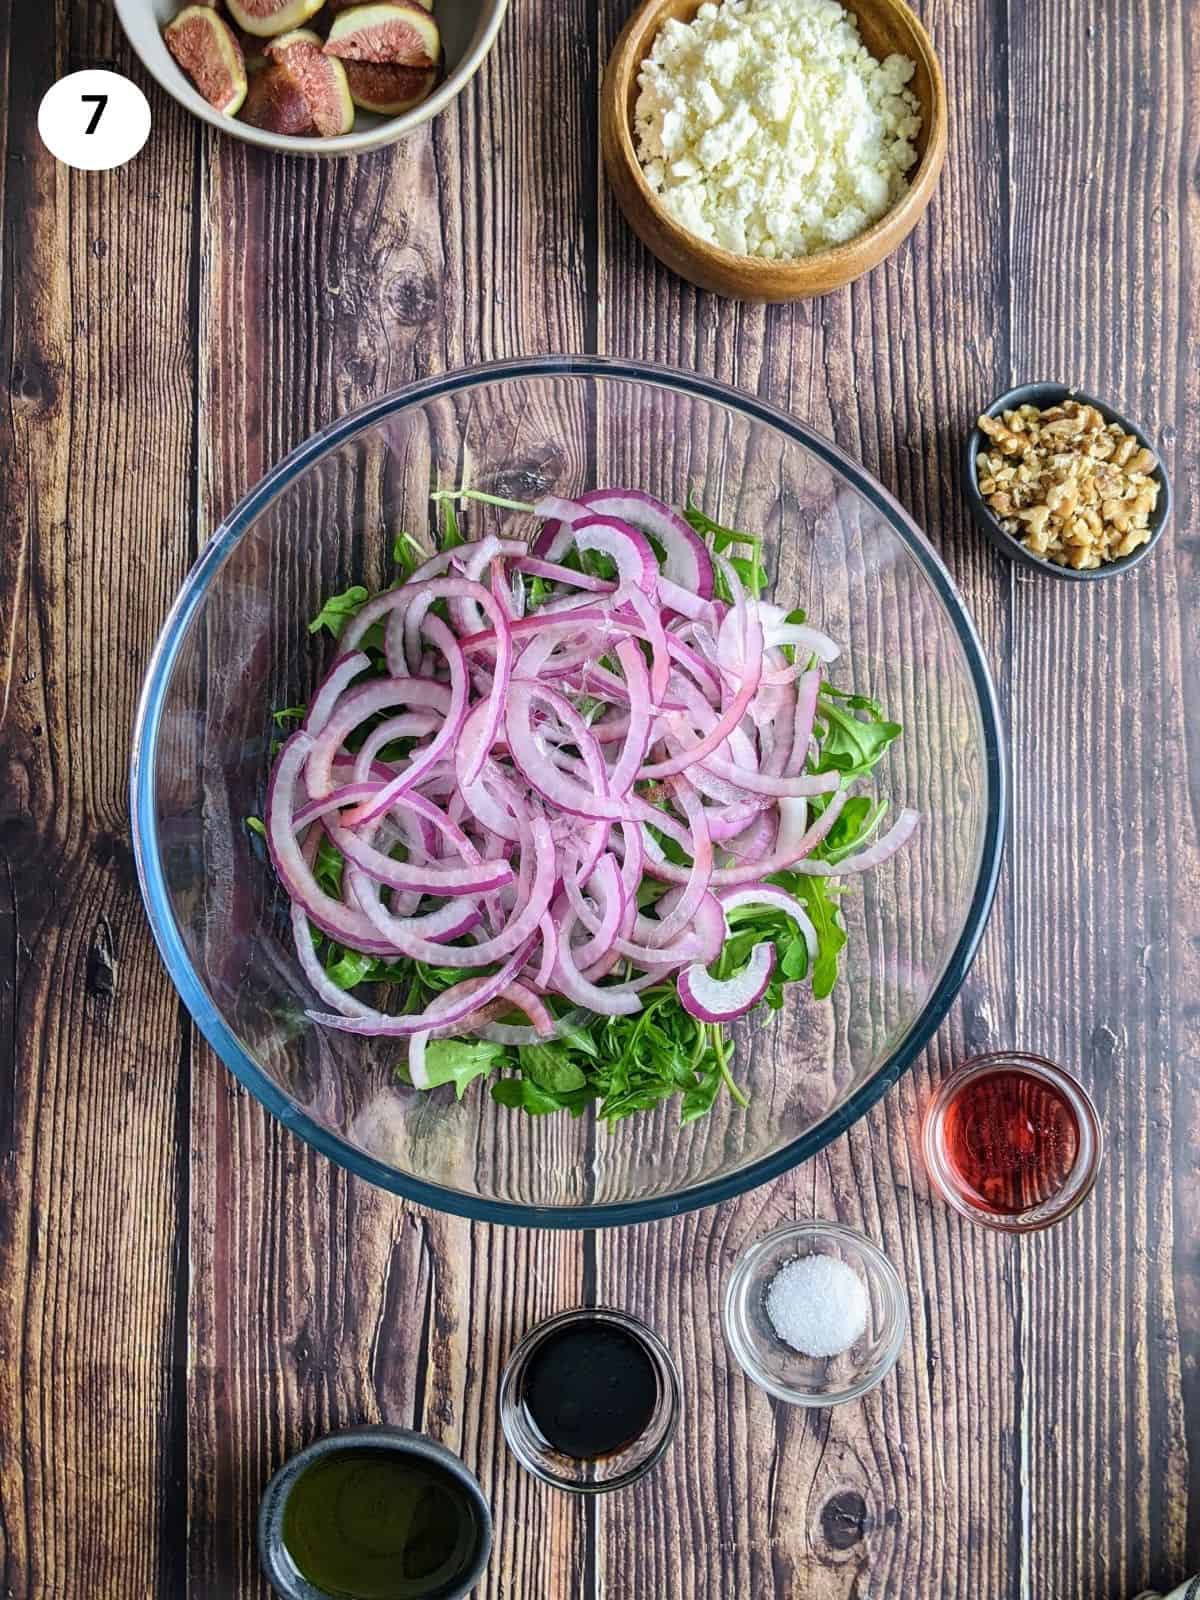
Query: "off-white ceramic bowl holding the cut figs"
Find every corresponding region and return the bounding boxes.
[115,0,509,155]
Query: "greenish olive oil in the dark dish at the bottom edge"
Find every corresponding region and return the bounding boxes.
[282,1446,480,1600]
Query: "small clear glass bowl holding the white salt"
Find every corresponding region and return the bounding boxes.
[725,1221,909,1406]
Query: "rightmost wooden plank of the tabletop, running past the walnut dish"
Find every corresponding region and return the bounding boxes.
[1010,3,1200,1594]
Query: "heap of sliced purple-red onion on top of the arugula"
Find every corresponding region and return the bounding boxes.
[266,505,915,1043]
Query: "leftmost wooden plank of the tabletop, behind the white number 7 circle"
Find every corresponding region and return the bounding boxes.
[0,3,195,1600]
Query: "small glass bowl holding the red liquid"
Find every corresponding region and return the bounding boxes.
[922,1050,1104,1234]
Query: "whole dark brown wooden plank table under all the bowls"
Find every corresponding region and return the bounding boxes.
[0,0,1200,1600]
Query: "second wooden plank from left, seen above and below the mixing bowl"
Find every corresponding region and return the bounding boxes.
[189,13,592,1600]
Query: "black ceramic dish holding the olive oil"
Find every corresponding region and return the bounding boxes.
[258,1424,491,1600]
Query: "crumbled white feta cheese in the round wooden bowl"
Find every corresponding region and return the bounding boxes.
[634,0,922,261]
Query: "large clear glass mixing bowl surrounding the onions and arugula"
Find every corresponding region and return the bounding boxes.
[131,357,1005,1227]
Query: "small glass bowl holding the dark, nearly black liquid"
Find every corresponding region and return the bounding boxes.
[499,1306,682,1494]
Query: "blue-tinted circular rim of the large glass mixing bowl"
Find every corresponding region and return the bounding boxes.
[130,355,1008,1229]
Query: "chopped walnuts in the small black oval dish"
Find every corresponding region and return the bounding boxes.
[976,400,1160,571]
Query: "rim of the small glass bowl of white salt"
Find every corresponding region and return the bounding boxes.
[722,1216,909,1411]
